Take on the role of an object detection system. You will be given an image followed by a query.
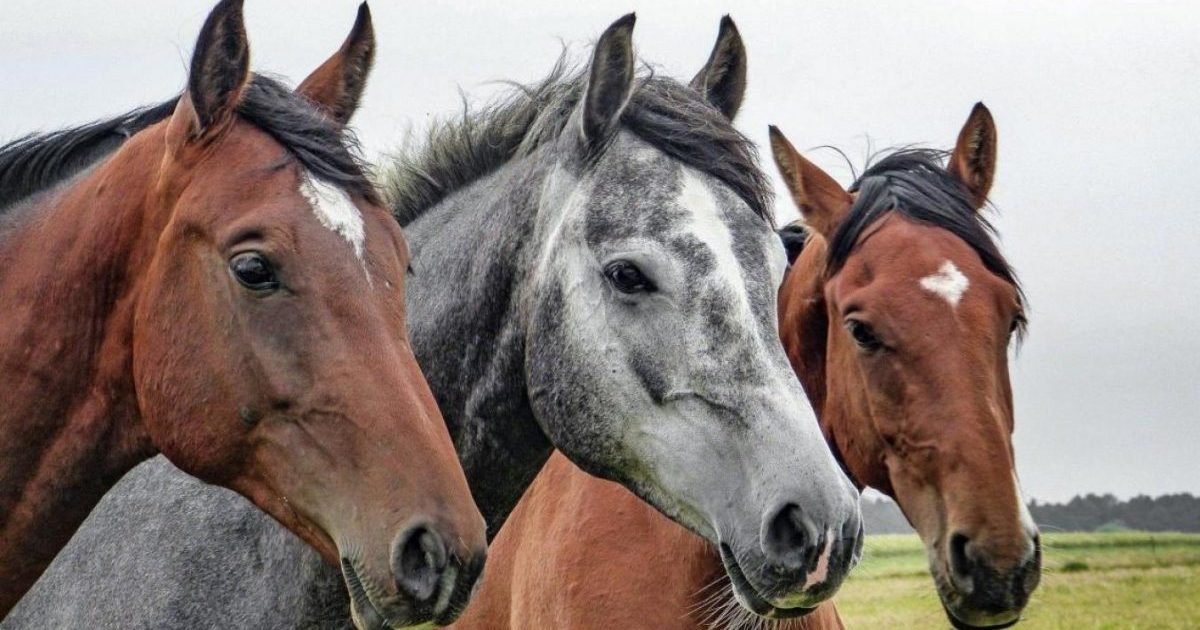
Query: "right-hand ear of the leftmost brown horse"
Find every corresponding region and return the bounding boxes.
[296,2,376,125]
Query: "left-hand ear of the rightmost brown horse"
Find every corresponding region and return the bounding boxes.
[770,125,854,239]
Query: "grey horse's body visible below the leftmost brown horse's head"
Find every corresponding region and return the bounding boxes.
[0,456,352,630]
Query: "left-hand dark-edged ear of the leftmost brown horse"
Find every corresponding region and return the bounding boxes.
[187,0,250,136]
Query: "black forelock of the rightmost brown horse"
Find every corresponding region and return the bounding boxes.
[827,148,1026,332]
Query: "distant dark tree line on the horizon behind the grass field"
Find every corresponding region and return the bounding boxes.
[863,493,1200,534]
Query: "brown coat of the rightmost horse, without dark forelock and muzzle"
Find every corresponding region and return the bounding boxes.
[455,106,1028,630]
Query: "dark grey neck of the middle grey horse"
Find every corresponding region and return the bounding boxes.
[404,154,553,540]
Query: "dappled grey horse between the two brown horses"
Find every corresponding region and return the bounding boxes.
[7,14,862,628]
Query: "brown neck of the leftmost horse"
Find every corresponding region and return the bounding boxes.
[0,126,162,609]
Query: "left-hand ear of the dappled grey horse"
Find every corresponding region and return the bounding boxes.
[583,13,637,145]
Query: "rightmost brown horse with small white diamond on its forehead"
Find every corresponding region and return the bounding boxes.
[457,104,1040,629]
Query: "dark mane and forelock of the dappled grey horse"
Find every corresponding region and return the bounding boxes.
[383,54,774,226]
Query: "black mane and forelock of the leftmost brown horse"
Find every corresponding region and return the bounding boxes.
[0,74,378,212]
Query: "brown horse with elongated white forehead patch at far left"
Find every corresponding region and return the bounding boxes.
[0,0,485,628]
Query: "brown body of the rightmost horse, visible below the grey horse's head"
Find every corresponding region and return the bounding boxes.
[452,451,842,630]
